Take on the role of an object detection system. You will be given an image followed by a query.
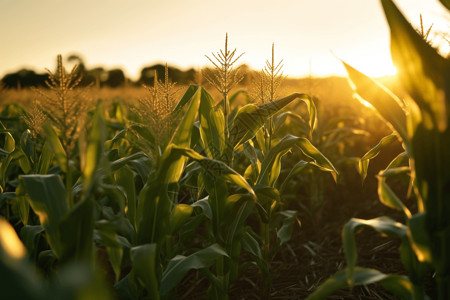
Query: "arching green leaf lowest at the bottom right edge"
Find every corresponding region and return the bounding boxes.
[306,267,419,300]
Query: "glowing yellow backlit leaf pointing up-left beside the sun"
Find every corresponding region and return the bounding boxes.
[342,62,409,148]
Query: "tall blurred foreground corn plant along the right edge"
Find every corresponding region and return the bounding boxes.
[309,0,450,299]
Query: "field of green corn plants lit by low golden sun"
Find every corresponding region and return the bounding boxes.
[0,0,450,300]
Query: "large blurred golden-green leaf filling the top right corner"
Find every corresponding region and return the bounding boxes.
[381,0,450,131]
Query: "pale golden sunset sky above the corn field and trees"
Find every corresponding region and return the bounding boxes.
[0,0,449,79]
